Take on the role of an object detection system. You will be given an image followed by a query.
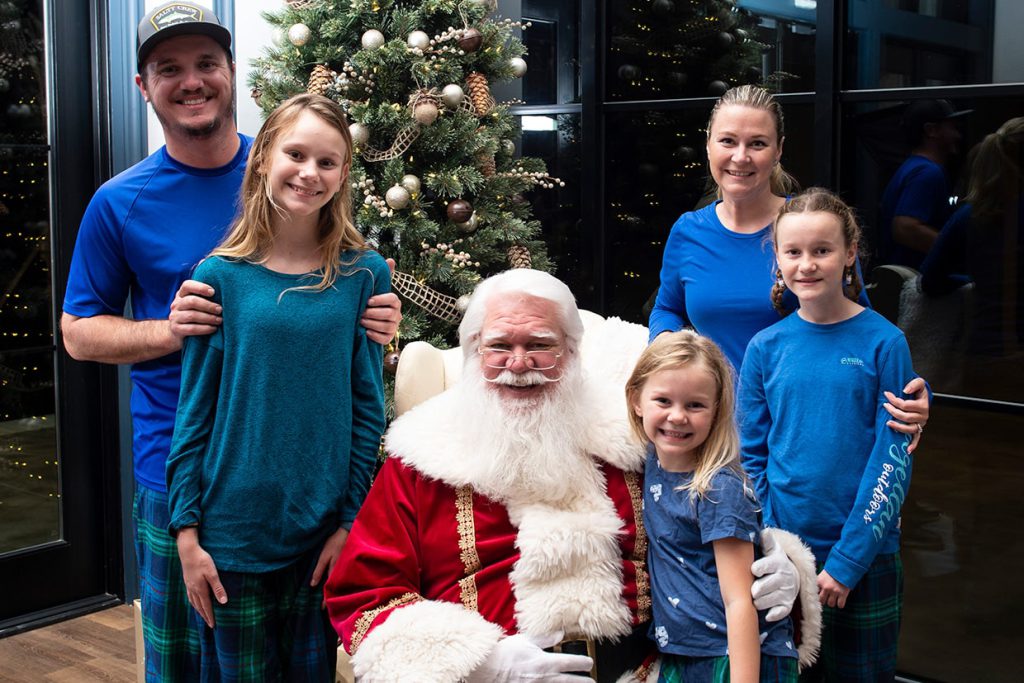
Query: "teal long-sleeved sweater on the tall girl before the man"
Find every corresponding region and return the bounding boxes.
[167,251,390,572]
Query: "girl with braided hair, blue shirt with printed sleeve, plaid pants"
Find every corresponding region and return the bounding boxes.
[739,188,914,681]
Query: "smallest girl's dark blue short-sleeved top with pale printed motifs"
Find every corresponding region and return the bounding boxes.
[643,447,797,657]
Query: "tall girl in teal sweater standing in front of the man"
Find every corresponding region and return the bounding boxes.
[167,95,389,681]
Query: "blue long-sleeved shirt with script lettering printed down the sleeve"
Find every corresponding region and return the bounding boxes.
[739,309,914,589]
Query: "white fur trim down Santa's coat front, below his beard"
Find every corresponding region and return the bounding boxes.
[509,497,632,639]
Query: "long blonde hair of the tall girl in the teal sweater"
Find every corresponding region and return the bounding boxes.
[210,94,367,291]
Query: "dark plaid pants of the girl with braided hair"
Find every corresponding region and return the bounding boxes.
[800,553,903,683]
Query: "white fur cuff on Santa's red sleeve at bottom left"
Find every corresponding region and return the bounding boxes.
[352,600,504,683]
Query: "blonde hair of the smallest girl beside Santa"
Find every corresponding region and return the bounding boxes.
[626,330,745,498]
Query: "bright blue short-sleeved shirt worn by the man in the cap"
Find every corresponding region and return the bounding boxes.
[63,134,252,492]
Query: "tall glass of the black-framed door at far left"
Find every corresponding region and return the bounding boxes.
[0,3,60,553]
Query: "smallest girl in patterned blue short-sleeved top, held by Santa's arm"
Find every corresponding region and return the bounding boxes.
[626,331,798,683]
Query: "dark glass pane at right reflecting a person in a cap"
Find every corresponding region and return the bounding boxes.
[841,97,1024,402]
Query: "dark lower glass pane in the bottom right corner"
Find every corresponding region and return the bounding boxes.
[899,405,1024,683]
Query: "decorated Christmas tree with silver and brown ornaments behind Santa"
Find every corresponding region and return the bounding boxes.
[249,0,560,352]
